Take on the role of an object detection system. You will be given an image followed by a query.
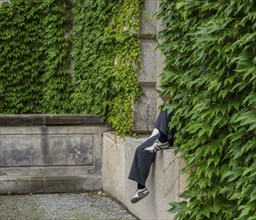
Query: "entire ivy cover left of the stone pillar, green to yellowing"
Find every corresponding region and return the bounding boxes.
[0,0,142,134]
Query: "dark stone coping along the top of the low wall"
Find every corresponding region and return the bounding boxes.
[0,114,103,126]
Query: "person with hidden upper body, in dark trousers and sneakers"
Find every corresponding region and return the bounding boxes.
[128,111,175,203]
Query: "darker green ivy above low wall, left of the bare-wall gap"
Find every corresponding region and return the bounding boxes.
[0,0,72,113]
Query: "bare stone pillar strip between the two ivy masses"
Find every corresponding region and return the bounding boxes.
[134,0,163,133]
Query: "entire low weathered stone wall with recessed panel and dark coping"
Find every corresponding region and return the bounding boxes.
[0,115,103,194]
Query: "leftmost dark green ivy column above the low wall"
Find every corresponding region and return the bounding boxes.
[0,1,43,113]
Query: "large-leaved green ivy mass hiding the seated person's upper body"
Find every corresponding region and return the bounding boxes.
[158,0,256,220]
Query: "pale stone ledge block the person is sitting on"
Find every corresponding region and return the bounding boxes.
[103,133,186,220]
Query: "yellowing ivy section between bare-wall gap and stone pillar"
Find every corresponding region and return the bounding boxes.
[72,0,142,134]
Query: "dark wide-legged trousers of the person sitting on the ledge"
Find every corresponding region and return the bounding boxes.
[128,111,174,185]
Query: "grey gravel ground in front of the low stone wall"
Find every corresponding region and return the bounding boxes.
[0,192,136,220]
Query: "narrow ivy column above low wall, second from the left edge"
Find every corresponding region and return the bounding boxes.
[41,0,73,113]
